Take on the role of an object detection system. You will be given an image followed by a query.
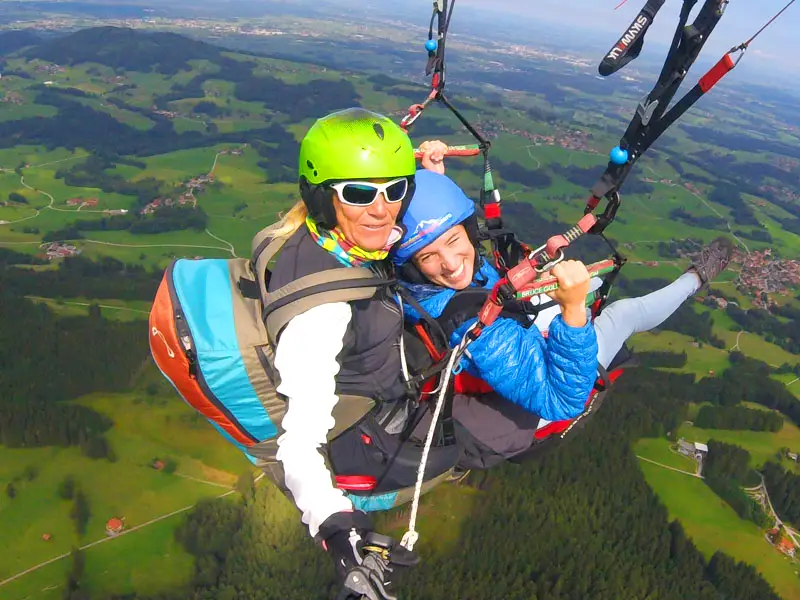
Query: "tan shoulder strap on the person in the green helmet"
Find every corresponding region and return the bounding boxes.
[251,230,395,344]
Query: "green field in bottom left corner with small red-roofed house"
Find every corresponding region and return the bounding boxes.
[0,368,251,598]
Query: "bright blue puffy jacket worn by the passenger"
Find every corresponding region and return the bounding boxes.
[404,260,597,421]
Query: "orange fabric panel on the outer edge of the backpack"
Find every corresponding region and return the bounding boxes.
[149,273,253,446]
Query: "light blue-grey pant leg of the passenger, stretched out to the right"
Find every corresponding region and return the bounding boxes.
[594,273,700,368]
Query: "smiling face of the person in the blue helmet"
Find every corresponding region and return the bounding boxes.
[413,225,475,290]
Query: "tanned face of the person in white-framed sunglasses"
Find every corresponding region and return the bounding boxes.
[333,179,402,252]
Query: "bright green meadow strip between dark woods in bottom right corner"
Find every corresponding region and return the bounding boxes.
[639,461,800,600]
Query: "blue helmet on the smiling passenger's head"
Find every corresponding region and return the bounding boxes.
[393,169,475,265]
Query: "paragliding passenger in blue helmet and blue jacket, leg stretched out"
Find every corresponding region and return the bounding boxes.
[393,142,733,466]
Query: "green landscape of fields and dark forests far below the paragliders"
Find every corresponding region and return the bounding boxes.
[0,27,800,600]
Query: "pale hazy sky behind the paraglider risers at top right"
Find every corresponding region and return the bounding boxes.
[454,0,800,66]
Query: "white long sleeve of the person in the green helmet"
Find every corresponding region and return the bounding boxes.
[275,302,353,537]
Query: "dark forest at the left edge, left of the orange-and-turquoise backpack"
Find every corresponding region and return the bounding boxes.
[0,251,157,460]
